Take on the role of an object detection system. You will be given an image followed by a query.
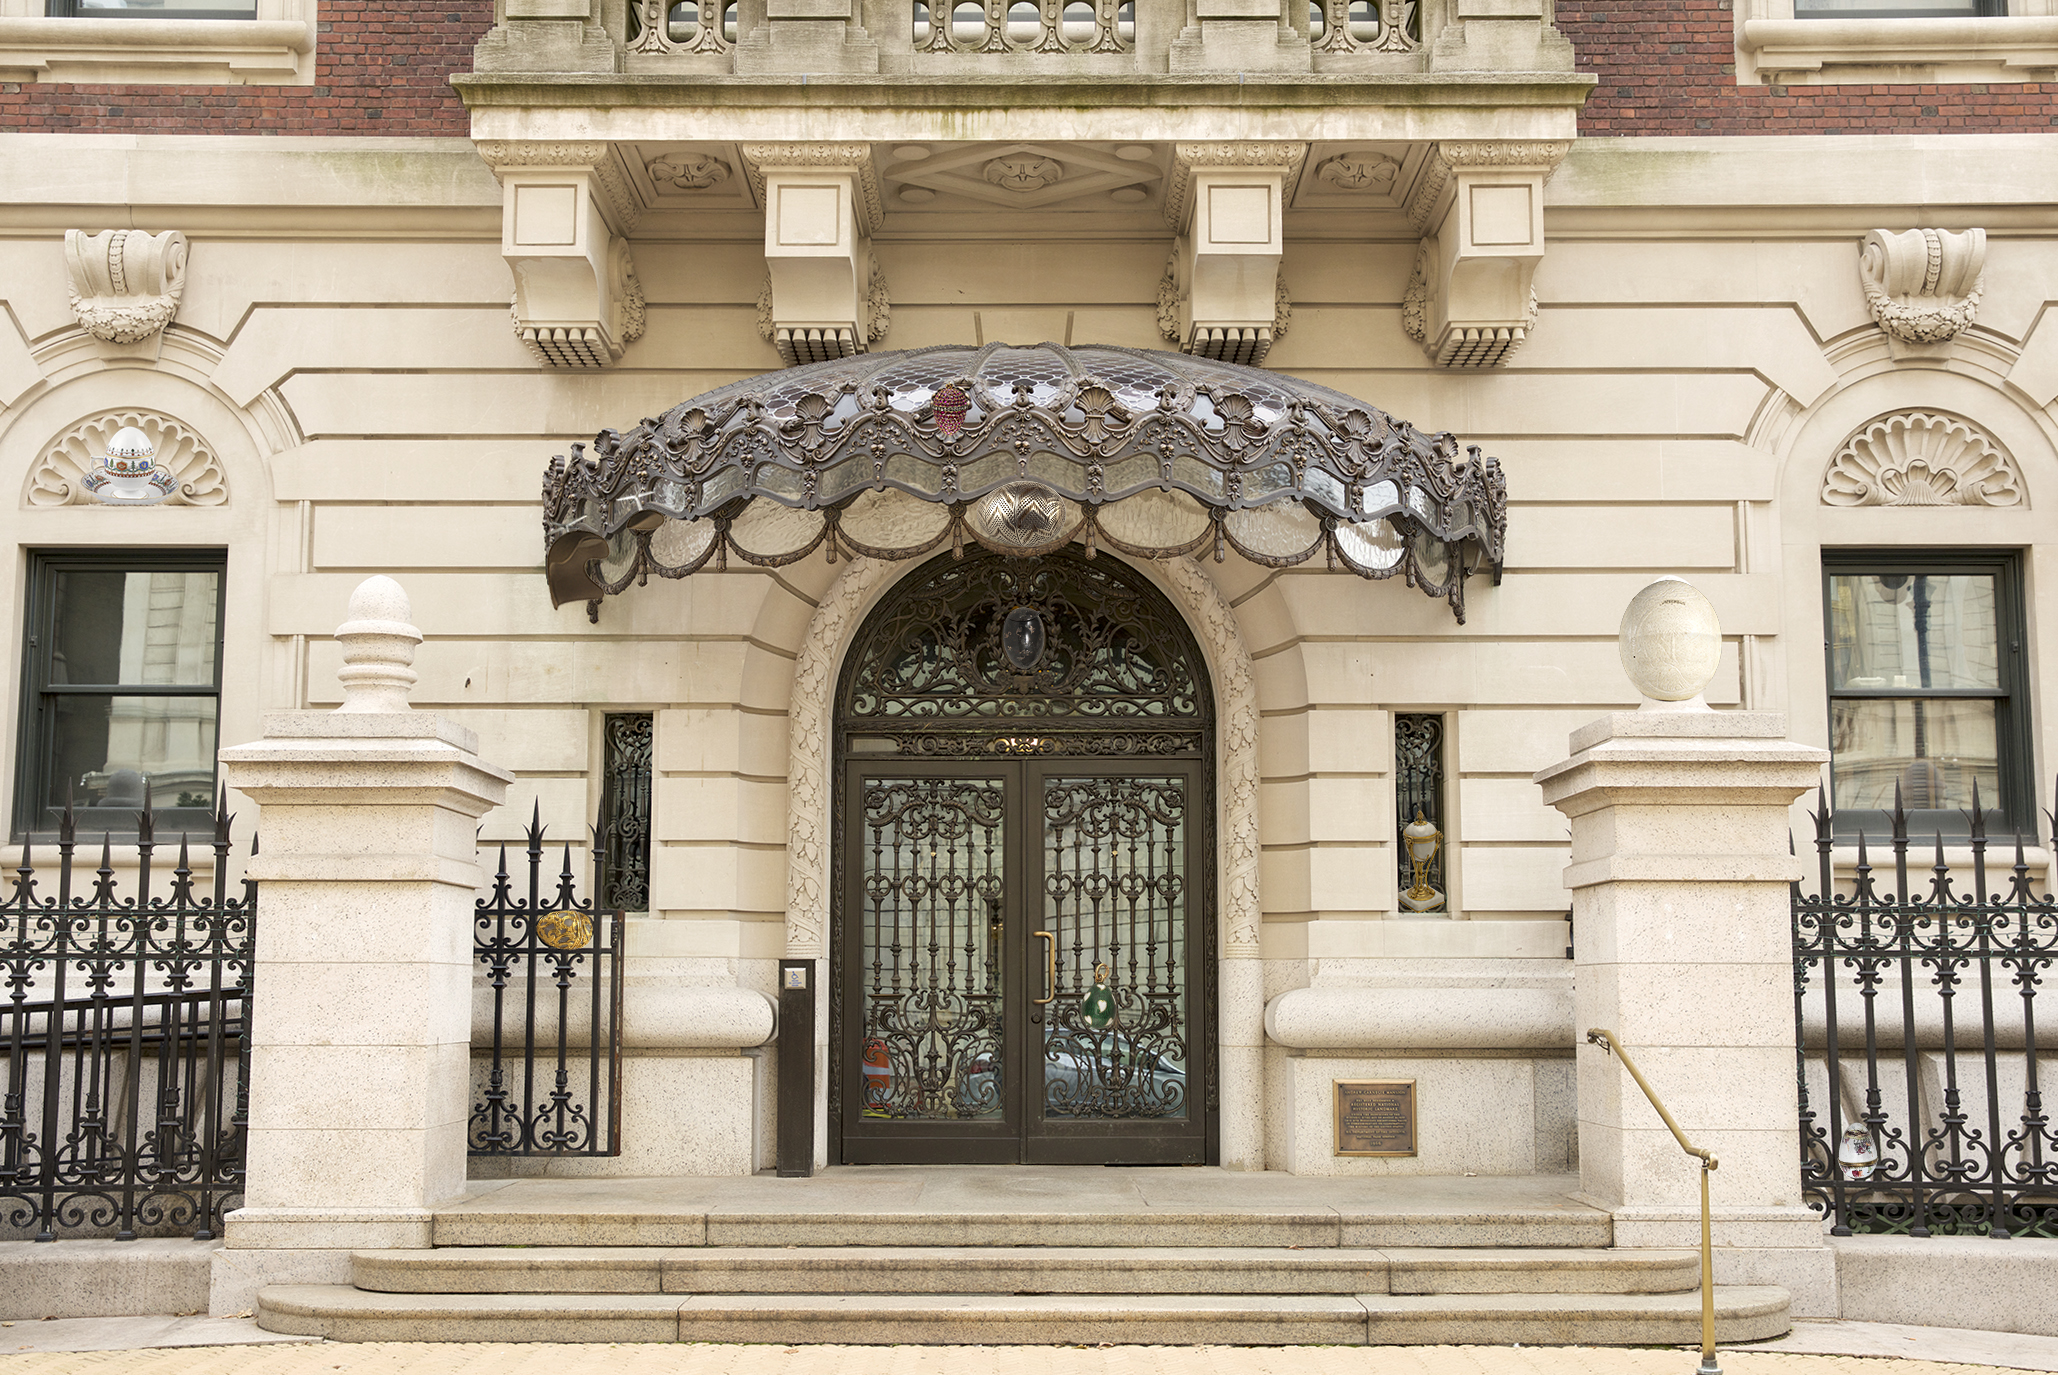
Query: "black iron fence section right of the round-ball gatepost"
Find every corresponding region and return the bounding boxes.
[1793,790,2058,1237]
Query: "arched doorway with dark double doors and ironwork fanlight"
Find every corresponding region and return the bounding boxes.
[829,550,1218,1165]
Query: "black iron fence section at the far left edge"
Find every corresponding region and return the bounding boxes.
[0,799,257,1241]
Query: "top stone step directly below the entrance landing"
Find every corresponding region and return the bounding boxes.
[421,1194,1613,1247]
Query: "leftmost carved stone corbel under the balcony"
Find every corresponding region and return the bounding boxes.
[480,142,644,368]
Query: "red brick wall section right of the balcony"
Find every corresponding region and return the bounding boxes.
[1558,0,2058,134]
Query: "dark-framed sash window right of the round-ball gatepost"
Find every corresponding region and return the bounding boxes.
[1821,550,2033,838]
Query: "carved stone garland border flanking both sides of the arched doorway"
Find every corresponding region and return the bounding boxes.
[786,558,1264,959]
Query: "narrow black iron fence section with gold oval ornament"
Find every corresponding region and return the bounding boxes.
[469,809,624,1157]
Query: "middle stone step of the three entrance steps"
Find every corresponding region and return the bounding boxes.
[350,1245,1700,1295]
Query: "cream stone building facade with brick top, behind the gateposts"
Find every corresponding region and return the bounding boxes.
[0,0,2058,1267]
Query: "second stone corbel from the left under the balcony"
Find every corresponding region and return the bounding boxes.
[743,144,891,366]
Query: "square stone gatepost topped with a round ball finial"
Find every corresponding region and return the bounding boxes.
[1535,578,1836,1317]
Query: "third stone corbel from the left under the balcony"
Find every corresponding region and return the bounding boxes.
[1159,142,1307,366]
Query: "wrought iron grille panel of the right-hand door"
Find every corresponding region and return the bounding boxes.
[1041,776,1187,1120]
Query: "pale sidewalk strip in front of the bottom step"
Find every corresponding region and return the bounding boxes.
[0,1317,2058,1375]
